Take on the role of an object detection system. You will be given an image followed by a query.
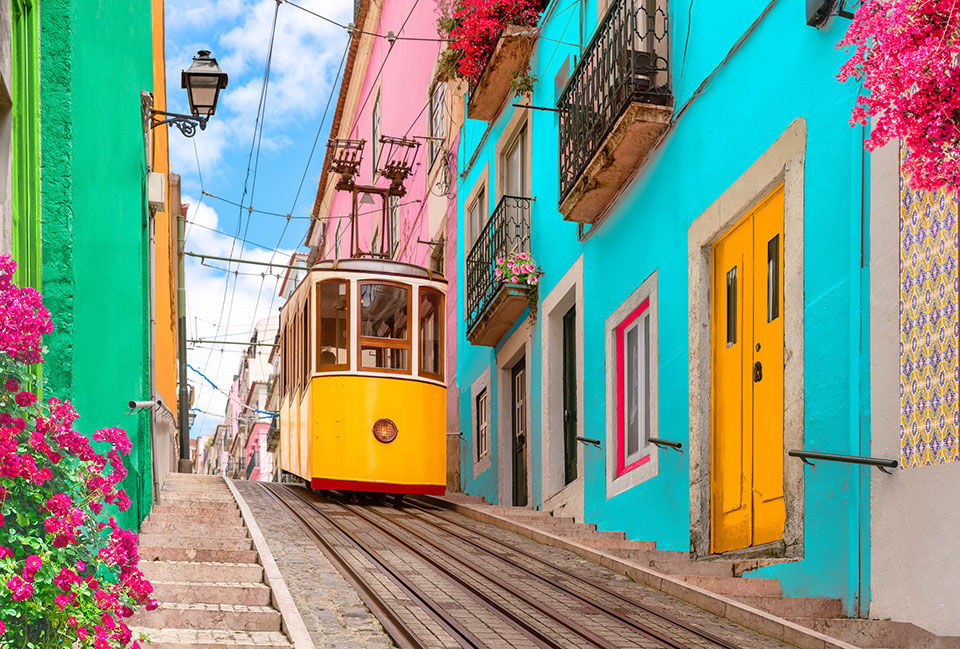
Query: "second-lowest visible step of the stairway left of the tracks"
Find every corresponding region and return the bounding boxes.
[132,602,281,631]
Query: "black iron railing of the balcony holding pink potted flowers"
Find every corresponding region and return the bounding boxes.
[466,196,531,335]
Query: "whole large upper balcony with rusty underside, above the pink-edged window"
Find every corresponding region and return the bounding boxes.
[557,0,673,223]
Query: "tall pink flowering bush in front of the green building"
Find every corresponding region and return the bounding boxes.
[0,255,156,649]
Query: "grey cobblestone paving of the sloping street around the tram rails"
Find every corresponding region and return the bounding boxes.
[235,481,790,649]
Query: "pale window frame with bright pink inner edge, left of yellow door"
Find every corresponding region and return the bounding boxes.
[604,272,660,499]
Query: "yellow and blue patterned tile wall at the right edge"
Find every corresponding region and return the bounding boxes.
[900,151,960,469]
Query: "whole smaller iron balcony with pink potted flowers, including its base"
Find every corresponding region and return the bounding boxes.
[466,196,531,347]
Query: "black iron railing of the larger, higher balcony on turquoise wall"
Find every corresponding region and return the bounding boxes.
[557,0,672,203]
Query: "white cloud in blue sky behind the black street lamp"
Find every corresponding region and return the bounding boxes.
[167,0,353,181]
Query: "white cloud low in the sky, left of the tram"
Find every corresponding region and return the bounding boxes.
[184,197,292,436]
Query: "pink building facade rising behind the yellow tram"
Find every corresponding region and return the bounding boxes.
[307,0,463,487]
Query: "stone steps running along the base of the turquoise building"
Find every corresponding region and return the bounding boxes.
[445,493,960,649]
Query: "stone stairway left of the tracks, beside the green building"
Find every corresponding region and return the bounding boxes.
[132,473,292,649]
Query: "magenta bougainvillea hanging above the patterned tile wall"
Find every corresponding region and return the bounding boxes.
[838,0,960,191]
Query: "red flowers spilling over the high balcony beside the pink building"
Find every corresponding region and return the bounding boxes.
[438,0,545,82]
